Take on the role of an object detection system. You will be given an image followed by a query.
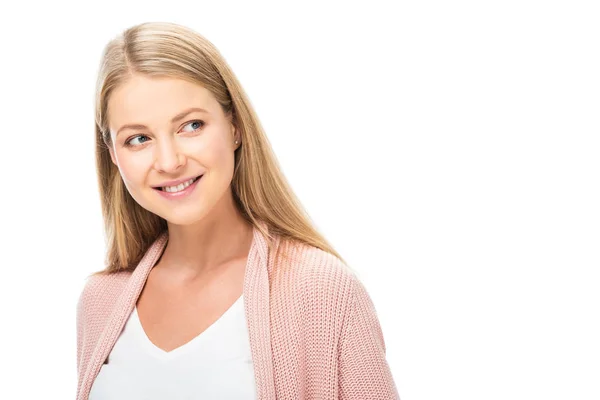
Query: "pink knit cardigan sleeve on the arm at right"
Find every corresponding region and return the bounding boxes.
[338,277,400,400]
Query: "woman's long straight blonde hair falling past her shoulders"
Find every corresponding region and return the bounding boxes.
[94,22,344,275]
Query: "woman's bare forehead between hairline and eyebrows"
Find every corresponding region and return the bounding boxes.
[108,75,219,129]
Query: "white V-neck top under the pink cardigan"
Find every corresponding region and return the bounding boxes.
[89,295,256,400]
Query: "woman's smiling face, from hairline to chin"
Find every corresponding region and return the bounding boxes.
[108,75,240,225]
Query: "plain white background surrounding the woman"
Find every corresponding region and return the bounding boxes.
[0,0,600,400]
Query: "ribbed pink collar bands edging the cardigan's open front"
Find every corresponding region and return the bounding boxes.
[80,221,279,400]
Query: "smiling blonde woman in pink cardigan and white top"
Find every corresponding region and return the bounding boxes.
[77,23,398,400]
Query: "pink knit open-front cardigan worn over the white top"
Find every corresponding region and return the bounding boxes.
[77,223,400,400]
